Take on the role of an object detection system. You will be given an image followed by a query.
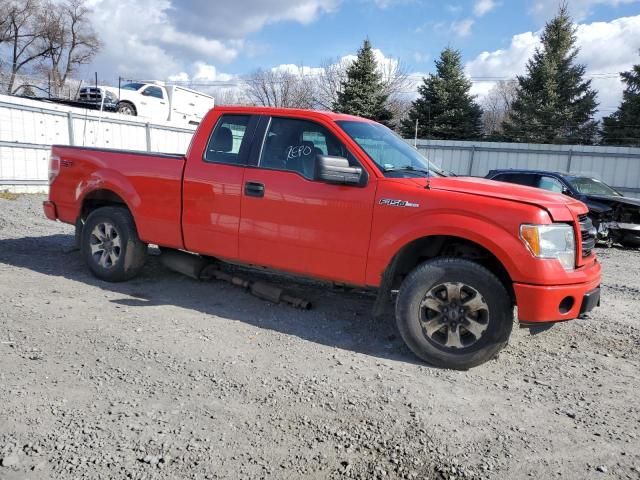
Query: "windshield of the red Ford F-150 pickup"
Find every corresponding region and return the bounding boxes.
[336,120,447,177]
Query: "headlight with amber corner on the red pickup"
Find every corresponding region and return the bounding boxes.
[520,223,576,270]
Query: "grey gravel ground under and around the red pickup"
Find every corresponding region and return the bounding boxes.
[0,195,640,479]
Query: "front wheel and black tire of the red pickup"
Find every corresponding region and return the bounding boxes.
[396,258,513,370]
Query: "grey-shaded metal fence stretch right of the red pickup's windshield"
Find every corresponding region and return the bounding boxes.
[410,140,640,197]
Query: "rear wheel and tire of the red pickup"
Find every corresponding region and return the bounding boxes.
[82,207,147,282]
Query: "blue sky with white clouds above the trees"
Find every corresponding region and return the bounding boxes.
[85,0,640,115]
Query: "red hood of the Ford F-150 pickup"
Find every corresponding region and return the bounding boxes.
[407,177,589,222]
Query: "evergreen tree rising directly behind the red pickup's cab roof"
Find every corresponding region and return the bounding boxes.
[333,39,392,123]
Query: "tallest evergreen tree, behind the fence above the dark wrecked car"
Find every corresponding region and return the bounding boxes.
[504,4,598,144]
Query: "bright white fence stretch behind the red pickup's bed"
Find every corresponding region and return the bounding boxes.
[0,95,195,192]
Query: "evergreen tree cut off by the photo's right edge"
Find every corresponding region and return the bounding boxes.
[602,54,640,147]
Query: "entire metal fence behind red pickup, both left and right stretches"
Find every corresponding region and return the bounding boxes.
[0,95,640,196]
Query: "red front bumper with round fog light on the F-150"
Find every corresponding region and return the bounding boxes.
[513,262,601,323]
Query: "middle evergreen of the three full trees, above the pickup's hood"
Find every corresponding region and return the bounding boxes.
[400,48,482,140]
